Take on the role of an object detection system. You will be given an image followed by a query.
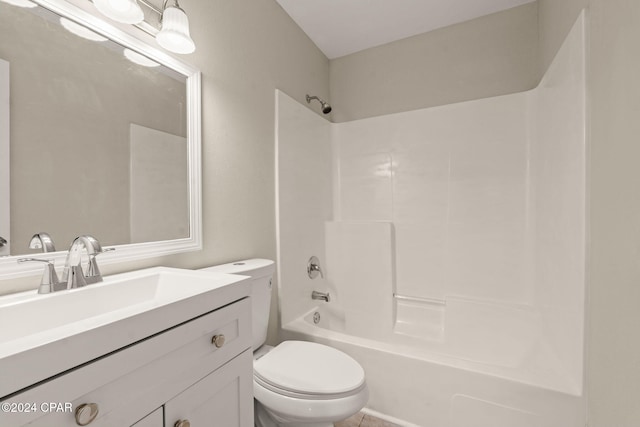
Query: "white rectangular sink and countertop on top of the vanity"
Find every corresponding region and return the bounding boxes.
[0,267,250,399]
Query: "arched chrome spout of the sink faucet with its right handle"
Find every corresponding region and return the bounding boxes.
[62,235,103,289]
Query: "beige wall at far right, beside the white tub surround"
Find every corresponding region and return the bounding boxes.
[539,0,640,427]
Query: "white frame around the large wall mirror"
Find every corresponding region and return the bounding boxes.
[0,0,202,280]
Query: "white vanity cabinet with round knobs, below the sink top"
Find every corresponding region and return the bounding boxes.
[0,298,253,427]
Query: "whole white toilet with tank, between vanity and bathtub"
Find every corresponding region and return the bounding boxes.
[202,259,369,427]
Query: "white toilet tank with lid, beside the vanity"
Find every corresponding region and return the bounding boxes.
[200,258,275,351]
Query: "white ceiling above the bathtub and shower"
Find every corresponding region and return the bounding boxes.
[276,0,534,59]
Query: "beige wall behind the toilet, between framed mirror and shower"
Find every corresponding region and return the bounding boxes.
[0,0,329,340]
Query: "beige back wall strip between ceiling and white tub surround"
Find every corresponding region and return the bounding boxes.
[330,2,541,122]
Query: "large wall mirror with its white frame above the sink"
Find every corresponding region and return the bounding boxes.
[0,0,201,278]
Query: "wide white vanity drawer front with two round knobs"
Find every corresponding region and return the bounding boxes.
[0,298,251,427]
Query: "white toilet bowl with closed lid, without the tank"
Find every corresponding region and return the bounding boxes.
[253,341,368,427]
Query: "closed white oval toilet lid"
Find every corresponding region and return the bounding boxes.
[253,341,364,395]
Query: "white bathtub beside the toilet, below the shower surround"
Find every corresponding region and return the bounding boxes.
[282,299,585,427]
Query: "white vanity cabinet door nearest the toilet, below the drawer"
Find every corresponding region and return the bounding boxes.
[164,349,253,427]
